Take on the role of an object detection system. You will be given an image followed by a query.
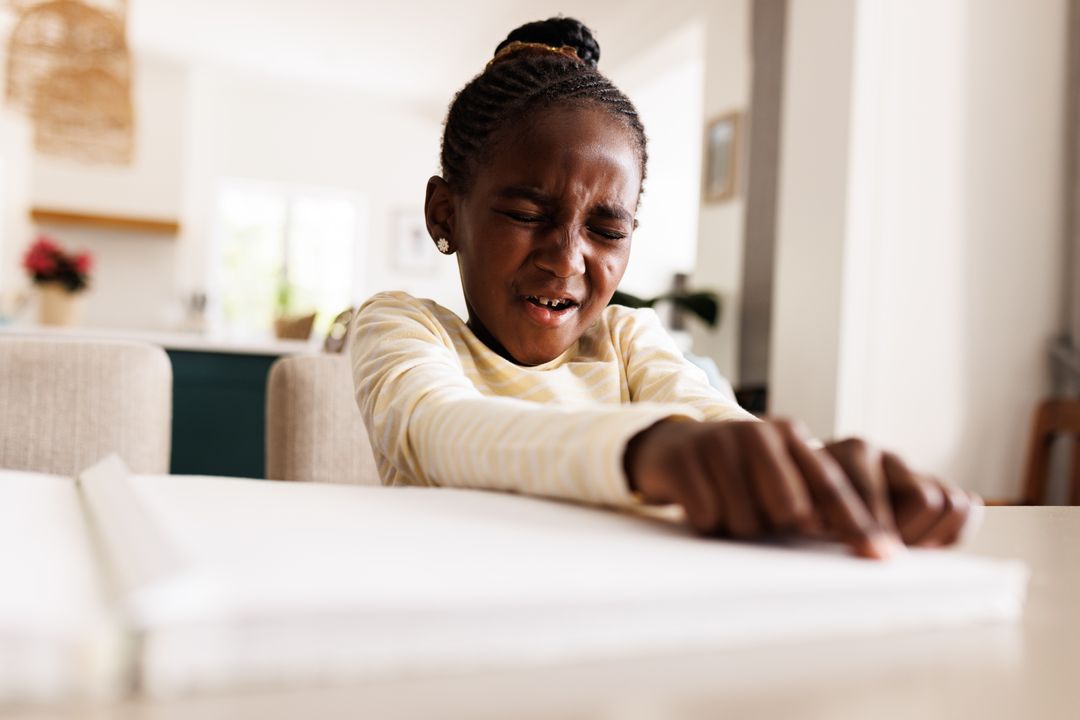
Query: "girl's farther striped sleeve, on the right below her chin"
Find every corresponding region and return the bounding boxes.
[611,310,755,420]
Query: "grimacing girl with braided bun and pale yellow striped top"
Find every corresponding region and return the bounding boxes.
[350,18,978,558]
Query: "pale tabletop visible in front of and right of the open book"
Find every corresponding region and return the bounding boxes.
[12,507,1080,720]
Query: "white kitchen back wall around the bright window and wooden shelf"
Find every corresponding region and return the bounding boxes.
[0,51,455,328]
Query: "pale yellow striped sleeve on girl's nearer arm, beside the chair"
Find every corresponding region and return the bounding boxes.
[350,294,700,504]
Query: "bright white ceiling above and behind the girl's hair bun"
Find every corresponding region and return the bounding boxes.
[129,0,696,107]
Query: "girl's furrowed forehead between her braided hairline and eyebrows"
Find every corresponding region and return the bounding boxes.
[476,105,642,205]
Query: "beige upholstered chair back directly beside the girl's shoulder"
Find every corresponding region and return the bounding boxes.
[267,354,379,485]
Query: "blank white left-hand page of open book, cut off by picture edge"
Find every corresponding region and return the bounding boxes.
[0,471,123,704]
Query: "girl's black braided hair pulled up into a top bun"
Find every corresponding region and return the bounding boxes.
[441,17,647,192]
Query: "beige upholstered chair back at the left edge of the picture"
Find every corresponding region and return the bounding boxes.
[0,337,173,476]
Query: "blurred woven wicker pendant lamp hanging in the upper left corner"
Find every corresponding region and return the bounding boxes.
[5,0,135,165]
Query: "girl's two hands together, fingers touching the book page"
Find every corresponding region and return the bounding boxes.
[624,420,982,558]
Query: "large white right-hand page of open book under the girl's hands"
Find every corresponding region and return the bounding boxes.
[73,459,1026,694]
